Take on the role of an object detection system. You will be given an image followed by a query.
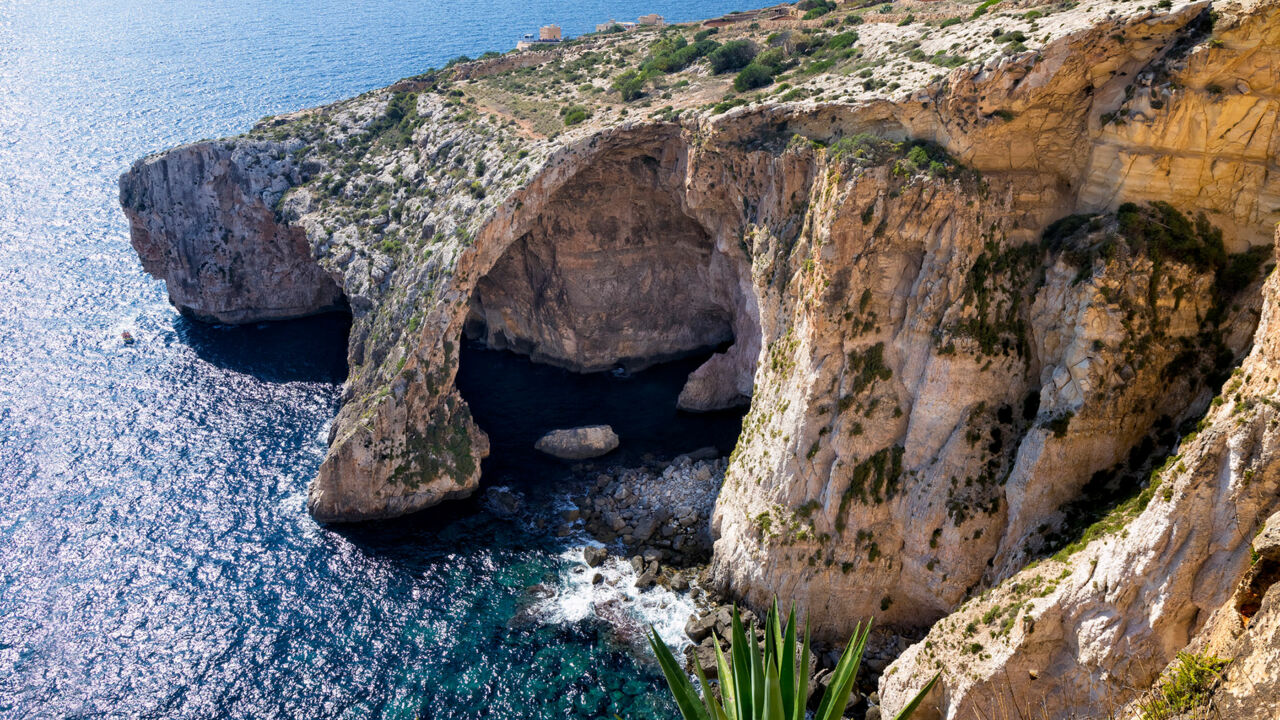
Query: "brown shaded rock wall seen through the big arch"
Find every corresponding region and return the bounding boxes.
[468,137,740,372]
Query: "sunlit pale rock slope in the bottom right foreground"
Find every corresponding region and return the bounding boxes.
[881,237,1280,719]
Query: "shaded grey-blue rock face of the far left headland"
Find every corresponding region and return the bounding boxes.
[120,142,346,323]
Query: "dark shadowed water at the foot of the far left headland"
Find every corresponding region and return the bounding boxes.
[173,311,351,384]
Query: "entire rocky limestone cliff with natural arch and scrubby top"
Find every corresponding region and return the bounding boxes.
[120,1,1280,717]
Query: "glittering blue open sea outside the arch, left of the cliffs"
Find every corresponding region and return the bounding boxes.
[0,0,749,719]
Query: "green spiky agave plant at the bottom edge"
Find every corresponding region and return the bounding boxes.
[649,601,938,720]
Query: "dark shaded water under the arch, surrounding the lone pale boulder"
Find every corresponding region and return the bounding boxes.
[456,338,746,487]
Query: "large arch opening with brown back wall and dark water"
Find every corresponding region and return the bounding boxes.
[457,141,760,482]
